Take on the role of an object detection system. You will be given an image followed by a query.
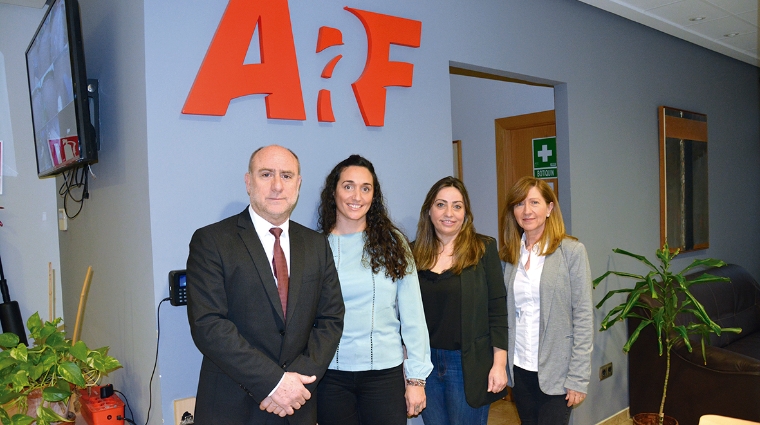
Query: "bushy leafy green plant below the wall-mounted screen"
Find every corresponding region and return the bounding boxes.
[0,313,121,425]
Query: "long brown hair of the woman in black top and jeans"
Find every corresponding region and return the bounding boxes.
[412,176,486,274]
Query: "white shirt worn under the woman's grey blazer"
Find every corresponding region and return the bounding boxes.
[514,234,546,372]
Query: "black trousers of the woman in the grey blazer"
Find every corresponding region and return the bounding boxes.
[512,366,573,425]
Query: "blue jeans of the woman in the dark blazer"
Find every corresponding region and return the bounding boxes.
[418,348,490,425]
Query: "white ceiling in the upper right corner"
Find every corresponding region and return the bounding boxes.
[580,0,760,67]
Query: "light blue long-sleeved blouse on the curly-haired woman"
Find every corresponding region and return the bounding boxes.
[328,232,433,379]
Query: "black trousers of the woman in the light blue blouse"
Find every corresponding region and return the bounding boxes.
[317,365,406,425]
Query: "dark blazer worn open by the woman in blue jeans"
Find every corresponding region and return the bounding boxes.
[461,235,507,407]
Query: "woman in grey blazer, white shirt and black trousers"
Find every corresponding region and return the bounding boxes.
[499,177,594,425]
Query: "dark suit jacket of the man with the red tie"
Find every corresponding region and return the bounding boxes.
[187,208,344,425]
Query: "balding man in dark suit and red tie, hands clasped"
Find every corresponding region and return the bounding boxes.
[187,145,344,425]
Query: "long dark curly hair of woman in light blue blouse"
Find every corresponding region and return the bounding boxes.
[317,155,413,282]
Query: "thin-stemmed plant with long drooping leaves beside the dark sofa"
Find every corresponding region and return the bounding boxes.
[594,242,741,425]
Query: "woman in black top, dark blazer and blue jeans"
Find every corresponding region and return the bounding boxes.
[413,177,507,425]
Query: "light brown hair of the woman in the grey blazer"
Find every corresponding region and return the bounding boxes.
[499,176,576,264]
